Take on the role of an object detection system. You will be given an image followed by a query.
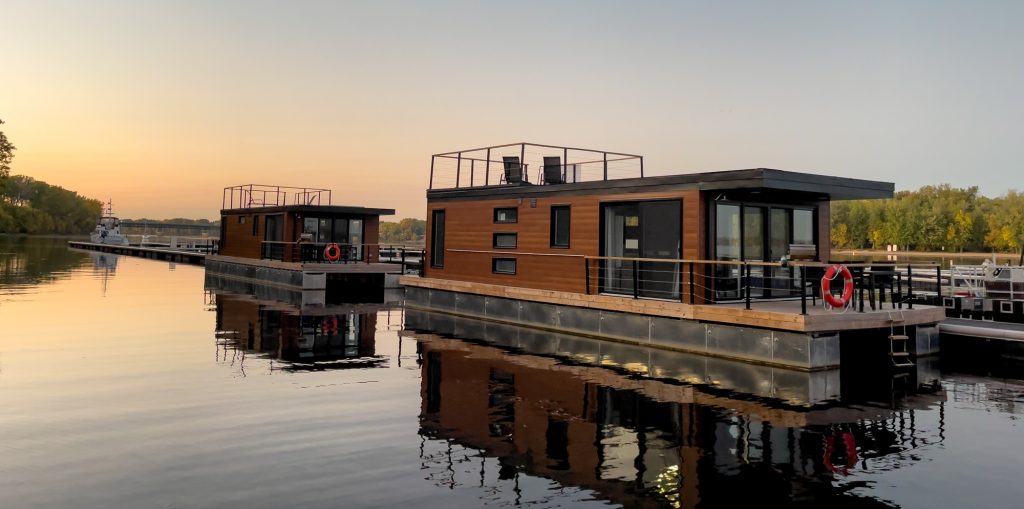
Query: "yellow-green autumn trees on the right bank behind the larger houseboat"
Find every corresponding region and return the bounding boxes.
[830,184,1024,253]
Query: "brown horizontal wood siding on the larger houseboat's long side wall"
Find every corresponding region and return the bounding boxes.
[425,189,705,293]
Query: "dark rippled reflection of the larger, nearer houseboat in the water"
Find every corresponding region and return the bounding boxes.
[408,311,946,507]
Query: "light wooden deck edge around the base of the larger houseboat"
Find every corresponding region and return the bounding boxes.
[399,275,945,333]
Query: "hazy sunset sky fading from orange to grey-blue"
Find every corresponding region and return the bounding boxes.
[0,0,1024,218]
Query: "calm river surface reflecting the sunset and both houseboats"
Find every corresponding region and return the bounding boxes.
[0,238,1024,508]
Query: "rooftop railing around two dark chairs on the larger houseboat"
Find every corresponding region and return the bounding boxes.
[429,142,643,189]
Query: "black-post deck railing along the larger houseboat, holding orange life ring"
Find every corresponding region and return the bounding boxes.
[434,249,948,314]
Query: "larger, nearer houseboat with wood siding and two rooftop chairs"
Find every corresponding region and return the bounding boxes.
[402,143,944,370]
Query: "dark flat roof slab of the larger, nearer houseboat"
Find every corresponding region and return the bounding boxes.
[427,168,896,201]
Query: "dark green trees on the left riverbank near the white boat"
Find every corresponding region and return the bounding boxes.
[0,175,102,234]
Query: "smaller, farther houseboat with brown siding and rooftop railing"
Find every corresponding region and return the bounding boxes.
[206,184,402,303]
